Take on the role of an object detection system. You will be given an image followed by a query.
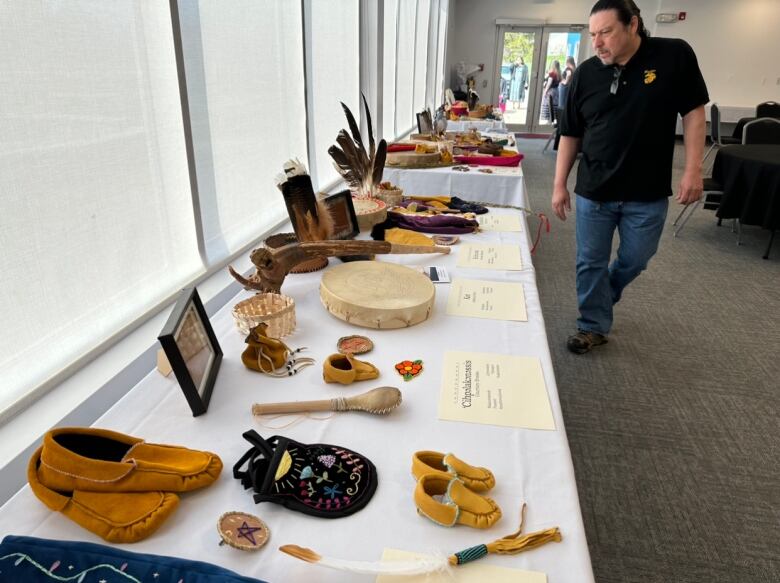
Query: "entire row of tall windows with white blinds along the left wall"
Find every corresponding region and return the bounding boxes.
[0,0,447,422]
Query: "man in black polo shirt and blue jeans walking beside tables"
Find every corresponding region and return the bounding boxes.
[552,0,709,354]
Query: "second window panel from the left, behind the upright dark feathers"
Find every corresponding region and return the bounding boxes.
[179,0,306,265]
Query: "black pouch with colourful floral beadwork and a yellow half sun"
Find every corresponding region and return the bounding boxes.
[233,430,377,518]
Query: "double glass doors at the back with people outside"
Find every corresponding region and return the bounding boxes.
[494,26,586,134]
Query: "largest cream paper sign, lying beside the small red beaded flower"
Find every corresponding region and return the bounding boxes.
[439,352,555,431]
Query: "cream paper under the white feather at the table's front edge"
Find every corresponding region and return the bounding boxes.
[376,549,547,583]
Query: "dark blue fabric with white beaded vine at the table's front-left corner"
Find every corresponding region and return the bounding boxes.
[0,535,263,583]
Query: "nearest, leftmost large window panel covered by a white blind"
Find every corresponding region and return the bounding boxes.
[0,0,203,420]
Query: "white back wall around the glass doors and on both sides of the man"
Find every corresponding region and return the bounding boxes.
[447,0,780,107]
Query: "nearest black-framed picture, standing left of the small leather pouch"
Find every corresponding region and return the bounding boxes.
[157,287,222,417]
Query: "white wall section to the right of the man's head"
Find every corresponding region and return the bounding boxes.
[651,0,780,107]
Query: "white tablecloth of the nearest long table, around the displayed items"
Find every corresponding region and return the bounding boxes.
[0,171,593,583]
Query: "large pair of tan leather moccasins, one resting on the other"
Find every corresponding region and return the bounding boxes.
[27,427,222,543]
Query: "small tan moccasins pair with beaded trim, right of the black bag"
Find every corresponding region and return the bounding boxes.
[412,451,501,528]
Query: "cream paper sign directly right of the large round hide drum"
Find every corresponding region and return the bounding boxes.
[447,279,528,322]
